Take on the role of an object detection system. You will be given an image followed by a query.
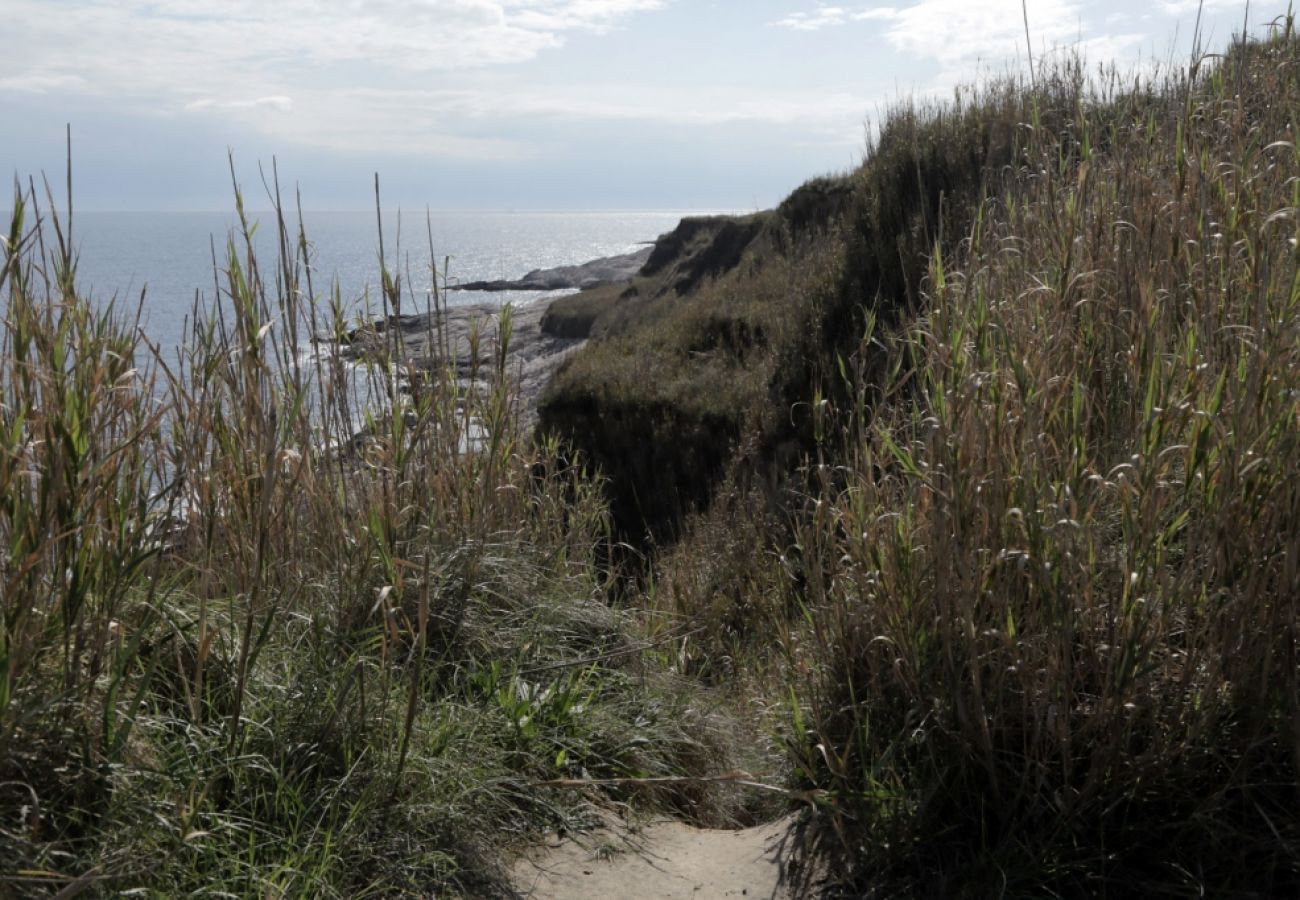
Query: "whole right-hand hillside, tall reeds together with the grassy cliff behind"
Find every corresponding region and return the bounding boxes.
[542,17,1300,897]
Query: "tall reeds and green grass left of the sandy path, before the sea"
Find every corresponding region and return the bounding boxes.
[0,159,748,896]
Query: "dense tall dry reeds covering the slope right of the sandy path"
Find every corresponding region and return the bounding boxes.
[789,16,1300,896]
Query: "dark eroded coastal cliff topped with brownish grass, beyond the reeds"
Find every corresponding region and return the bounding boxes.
[540,165,930,542]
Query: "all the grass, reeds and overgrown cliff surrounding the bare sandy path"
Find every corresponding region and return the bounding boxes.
[0,16,1300,897]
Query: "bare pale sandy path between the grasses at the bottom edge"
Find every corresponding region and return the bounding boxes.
[512,818,794,900]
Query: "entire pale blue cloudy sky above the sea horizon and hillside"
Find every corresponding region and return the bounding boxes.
[0,0,1286,211]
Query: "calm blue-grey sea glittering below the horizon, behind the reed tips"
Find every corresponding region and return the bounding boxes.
[65,211,699,347]
